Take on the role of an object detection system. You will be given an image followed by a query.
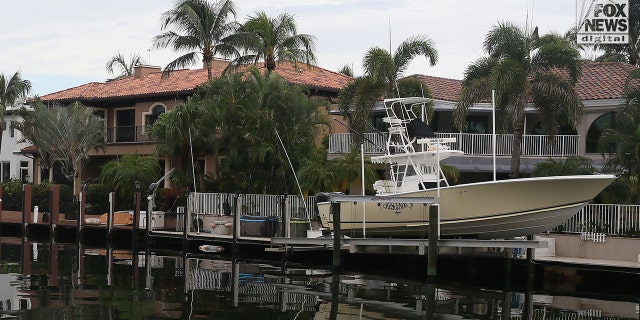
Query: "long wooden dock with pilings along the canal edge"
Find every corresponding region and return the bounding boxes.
[0,185,640,282]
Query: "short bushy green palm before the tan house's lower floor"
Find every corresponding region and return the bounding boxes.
[100,152,160,197]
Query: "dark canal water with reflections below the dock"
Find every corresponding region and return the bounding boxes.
[0,237,640,320]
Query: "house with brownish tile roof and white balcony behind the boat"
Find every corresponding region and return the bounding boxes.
[329,61,636,180]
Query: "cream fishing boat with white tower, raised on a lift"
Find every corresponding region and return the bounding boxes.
[316,97,616,239]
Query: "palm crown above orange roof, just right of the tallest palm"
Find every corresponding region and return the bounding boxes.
[236,12,316,71]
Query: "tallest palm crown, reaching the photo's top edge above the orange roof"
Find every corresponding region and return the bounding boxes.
[154,0,239,79]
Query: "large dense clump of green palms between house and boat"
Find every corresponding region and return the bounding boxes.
[205,68,328,194]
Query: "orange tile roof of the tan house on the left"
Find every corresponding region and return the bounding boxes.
[40,63,351,101]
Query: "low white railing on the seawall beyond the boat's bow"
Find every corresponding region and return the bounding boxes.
[561,204,640,235]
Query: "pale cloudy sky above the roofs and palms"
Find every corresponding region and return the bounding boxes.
[0,0,588,96]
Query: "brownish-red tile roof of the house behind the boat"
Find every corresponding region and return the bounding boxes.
[410,61,637,102]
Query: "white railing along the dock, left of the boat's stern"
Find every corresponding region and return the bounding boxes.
[189,193,315,220]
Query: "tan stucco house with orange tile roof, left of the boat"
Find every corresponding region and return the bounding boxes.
[34,60,351,192]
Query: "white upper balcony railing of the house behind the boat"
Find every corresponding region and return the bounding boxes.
[329,133,580,157]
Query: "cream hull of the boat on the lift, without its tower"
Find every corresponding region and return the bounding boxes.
[317,175,615,239]
